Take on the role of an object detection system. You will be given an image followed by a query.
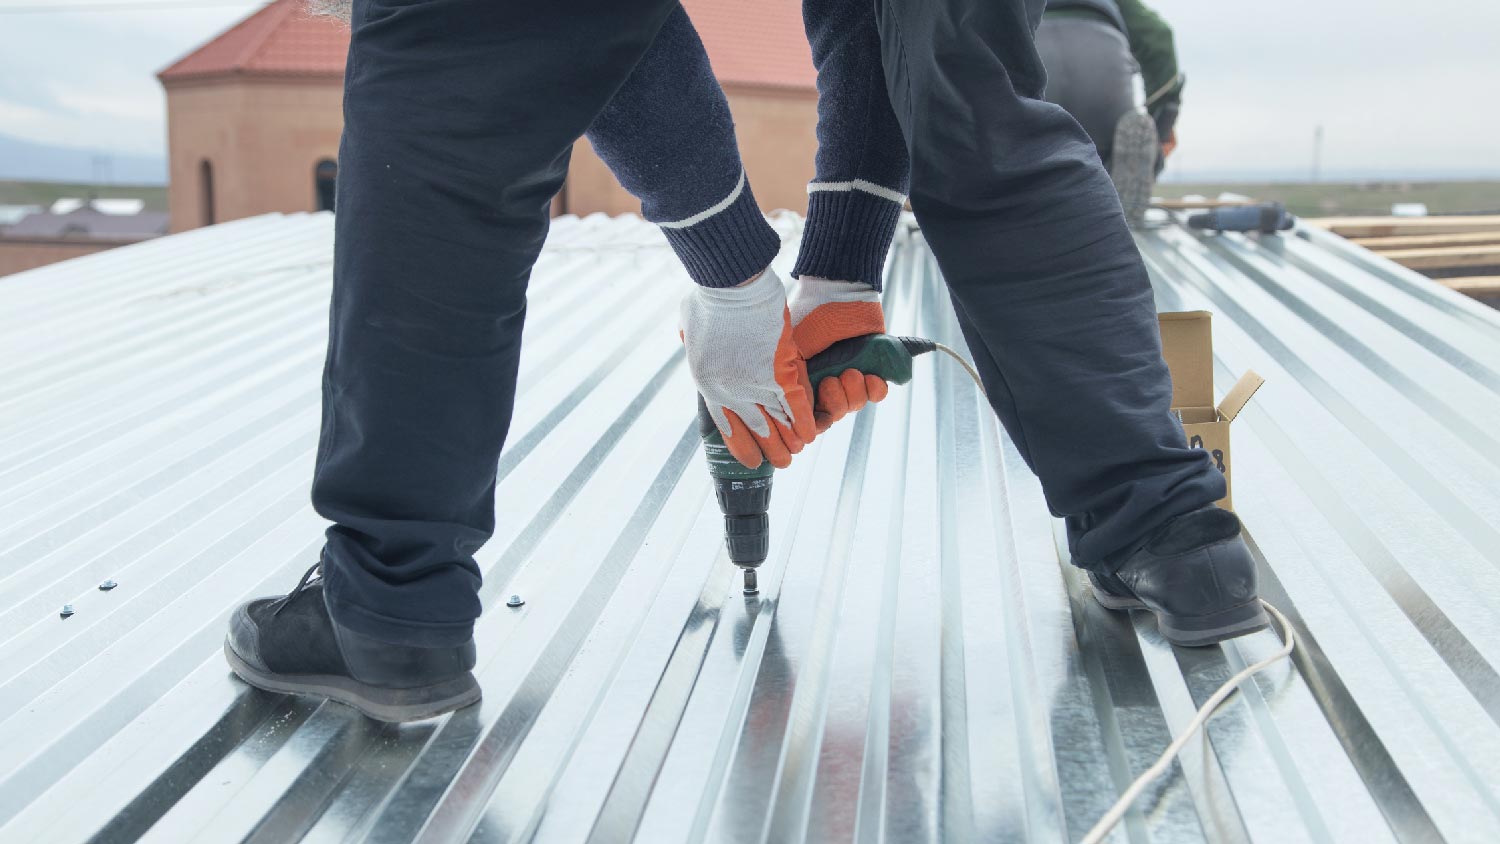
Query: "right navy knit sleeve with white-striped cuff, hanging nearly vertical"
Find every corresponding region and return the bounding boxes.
[792,0,911,291]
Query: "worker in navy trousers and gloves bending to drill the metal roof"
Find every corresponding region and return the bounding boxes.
[227,0,1266,721]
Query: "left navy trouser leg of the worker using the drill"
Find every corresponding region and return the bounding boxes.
[312,0,677,646]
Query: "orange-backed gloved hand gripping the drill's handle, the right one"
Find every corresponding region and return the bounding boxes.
[791,276,890,433]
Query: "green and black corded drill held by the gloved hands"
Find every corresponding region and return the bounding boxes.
[698,334,938,595]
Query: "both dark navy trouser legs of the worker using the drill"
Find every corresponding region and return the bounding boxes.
[314,0,1224,646]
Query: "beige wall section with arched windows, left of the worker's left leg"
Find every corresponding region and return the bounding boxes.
[167,76,344,231]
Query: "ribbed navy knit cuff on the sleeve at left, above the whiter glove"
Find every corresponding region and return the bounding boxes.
[659,180,782,288]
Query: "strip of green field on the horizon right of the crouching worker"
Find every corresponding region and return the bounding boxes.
[1157,181,1500,217]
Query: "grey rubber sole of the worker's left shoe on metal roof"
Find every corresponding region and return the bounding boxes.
[224,642,482,723]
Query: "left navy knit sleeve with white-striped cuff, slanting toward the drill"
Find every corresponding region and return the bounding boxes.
[588,7,782,288]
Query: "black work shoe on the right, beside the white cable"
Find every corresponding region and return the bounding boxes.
[1089,507,1271,646]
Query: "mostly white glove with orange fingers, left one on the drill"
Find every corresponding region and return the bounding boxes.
[683,270,818,469]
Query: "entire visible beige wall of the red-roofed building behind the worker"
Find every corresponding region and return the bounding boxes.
[167,76,818,231]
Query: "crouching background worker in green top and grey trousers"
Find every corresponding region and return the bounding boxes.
[1037,0,1185,225]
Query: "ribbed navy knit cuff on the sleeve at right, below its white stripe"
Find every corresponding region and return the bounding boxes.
[792,190,902,292]
